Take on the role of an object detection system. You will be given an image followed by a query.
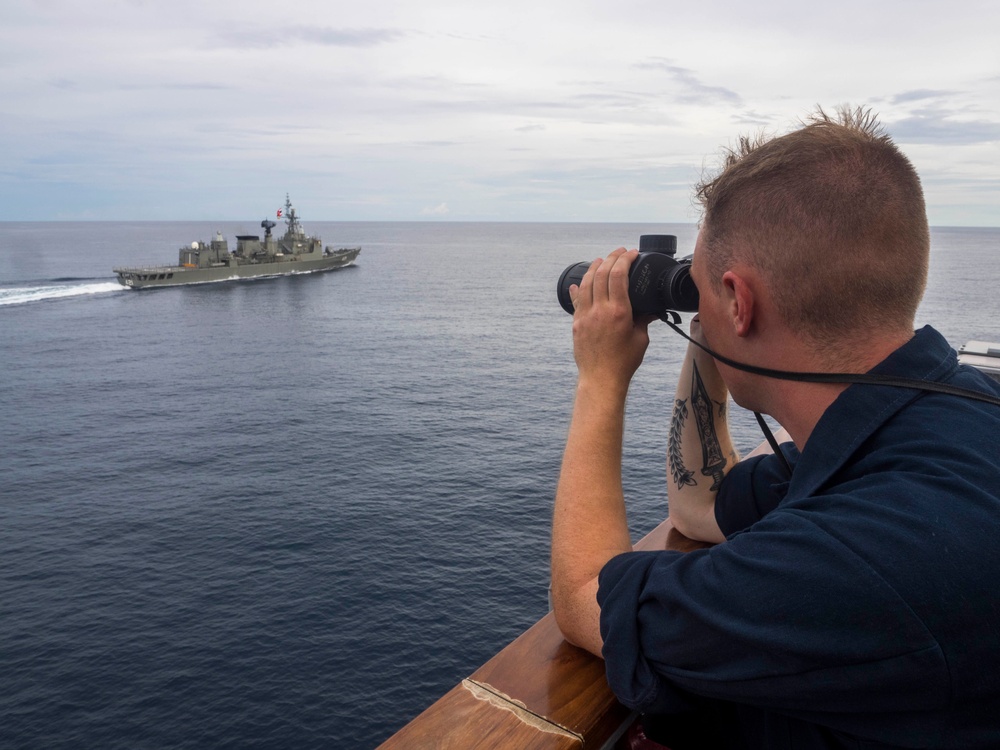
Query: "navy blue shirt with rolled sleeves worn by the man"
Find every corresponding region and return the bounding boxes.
[598,327,1000,750]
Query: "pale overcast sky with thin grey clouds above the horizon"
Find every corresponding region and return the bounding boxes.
[0,0,1000,226]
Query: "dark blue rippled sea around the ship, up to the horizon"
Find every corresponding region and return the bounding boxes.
[0,217,1000,750]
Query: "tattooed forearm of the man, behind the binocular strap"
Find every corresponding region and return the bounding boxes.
[667,344,739,542]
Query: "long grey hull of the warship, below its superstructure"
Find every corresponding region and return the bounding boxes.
[113,247,361,289]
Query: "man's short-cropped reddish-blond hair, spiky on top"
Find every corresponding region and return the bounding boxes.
[696,107,930,346]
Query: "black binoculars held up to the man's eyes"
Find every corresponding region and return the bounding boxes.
[556,234,698,318]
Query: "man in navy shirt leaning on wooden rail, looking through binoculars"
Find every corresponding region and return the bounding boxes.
[552,109,1000,750]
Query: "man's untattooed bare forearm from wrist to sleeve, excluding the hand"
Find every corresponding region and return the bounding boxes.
[552,382,632,656]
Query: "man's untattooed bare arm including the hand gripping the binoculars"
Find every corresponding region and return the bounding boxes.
[552,247,649,656]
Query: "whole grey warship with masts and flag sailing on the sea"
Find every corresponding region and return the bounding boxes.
[112,195,361,289]
